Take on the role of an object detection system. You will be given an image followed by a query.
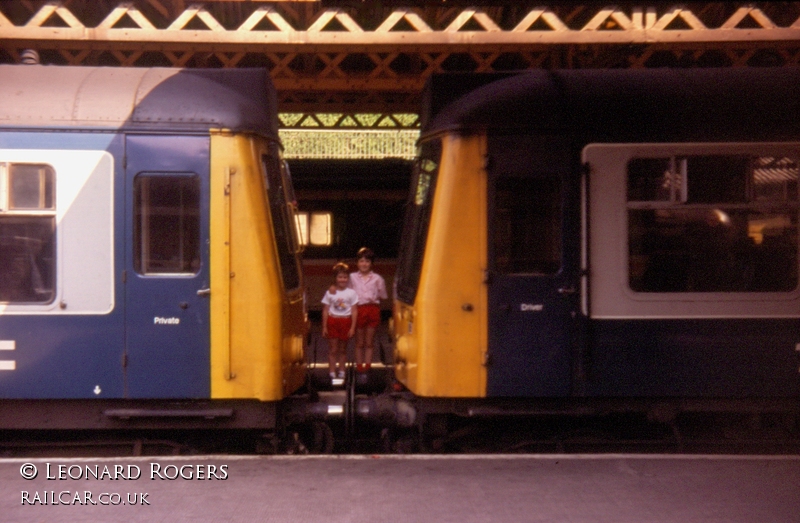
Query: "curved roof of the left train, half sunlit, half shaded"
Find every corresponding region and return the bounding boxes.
[0,65,278,138]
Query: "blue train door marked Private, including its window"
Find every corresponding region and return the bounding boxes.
[125,135,211,398]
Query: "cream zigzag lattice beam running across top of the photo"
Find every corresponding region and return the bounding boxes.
[0,2,800,47]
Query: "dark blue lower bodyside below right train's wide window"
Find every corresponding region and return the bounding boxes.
[587,319,800,398]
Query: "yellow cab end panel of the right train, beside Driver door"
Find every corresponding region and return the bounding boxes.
[394,135,487,398]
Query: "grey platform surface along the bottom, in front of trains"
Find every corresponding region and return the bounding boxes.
[0,455,800,523]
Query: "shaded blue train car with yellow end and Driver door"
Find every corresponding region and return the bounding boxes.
[394,67,800,415]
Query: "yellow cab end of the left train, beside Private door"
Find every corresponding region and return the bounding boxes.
[210,132,306,401]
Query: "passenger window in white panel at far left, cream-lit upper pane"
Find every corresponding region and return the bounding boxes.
[0,163,56,304]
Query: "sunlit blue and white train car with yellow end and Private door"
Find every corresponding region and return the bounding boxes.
[0,65,306,428]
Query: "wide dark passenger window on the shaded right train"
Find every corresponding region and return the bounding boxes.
[628,155,799,293]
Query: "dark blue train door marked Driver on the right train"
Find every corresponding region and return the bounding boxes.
[487,136,579,397]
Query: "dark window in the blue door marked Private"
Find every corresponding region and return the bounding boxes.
[134,174,200,274]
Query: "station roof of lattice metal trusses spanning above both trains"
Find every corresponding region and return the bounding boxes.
[0,0,800,156]
